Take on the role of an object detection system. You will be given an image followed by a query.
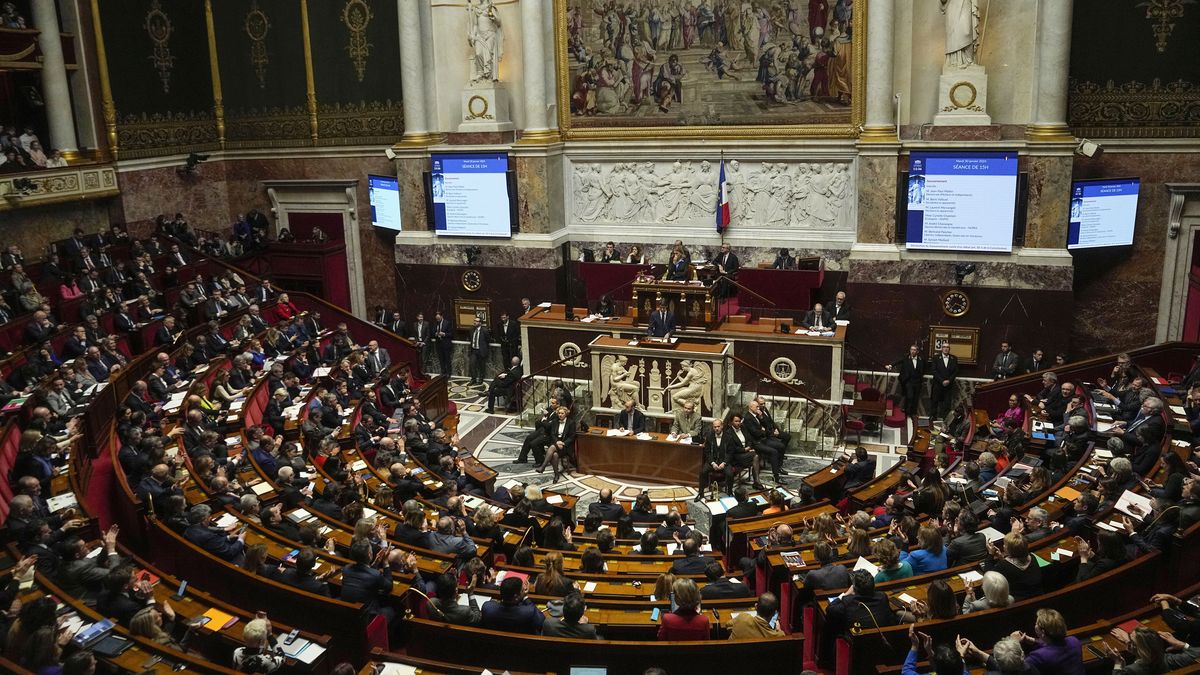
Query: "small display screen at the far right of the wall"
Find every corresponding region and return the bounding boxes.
[1067,178,1141,249]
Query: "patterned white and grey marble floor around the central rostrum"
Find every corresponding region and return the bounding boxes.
[450,376,899,532]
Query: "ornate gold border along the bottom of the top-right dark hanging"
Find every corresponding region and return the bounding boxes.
[1068,78,1200,138]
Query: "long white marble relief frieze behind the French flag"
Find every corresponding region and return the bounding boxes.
[571,160,851,229]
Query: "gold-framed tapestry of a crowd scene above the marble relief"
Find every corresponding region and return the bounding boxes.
[556,0,865,137]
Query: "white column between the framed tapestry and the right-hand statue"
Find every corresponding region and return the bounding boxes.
[859,0,896,143]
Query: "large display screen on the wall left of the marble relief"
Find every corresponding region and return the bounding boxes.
[430,154,512,237]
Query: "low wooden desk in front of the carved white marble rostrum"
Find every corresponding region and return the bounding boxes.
[575,429,703,485]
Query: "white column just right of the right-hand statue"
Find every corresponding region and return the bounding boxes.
[1025,0,1074,142]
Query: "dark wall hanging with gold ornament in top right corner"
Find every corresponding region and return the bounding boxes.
[1068,0,1200,138]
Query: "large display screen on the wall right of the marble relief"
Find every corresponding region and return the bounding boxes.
[905,151,1016,253]
